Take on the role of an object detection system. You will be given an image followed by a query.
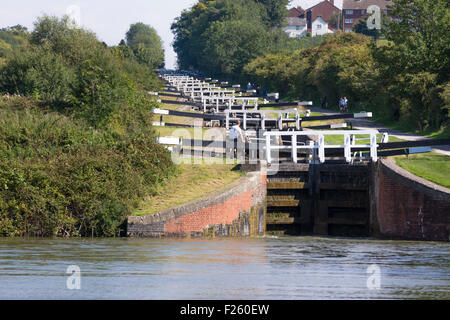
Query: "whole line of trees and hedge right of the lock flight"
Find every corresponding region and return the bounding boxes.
[172,0,450,131]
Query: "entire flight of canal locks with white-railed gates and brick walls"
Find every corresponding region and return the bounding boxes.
[127,70,450,241]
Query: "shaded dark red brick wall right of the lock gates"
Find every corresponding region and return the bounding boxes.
[377,162,450,241]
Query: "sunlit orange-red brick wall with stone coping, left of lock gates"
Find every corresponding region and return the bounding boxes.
[127,172,266,237]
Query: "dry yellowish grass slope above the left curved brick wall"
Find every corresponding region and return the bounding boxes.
[132,164,245,216]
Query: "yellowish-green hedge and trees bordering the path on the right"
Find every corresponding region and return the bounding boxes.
[243,0,450,132]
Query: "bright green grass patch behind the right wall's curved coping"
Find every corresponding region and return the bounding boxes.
[395,152,450,188]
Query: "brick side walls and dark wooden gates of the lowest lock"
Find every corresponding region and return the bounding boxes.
[127,159,450,241]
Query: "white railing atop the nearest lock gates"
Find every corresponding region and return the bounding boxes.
[264,130,384,163]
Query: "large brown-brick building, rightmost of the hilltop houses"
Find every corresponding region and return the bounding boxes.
[342,0,393,32]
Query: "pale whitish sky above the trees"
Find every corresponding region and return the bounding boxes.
[0,0,342,68]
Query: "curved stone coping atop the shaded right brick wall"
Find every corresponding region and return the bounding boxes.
[380,159,450,202]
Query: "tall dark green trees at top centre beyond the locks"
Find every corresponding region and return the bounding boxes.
[172,0,287,78]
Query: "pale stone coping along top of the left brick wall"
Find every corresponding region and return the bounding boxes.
[128,171,261,224]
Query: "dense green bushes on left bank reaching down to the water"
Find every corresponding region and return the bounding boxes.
[0,97,172,236]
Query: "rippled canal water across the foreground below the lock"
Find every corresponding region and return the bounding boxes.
[0,237,450,300]
